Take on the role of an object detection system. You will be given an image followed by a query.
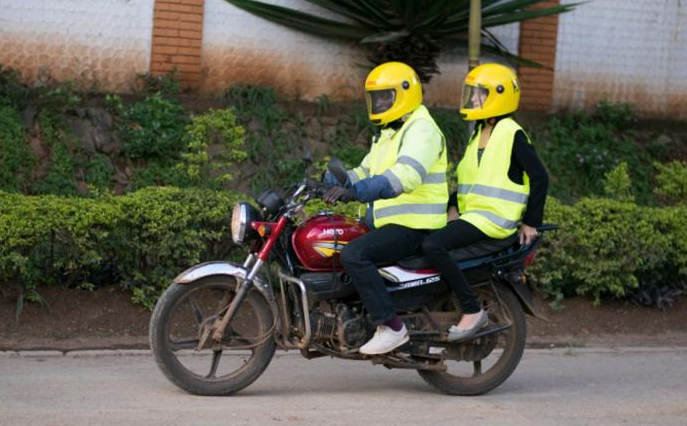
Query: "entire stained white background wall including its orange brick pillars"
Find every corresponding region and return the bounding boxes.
[0,0,687,119]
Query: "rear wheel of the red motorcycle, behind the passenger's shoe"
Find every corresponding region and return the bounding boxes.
[418,284,527,396]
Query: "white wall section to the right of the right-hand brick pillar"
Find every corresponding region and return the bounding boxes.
[553,0,687,119]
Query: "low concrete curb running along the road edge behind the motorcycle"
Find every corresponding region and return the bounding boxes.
[0,346,687,359]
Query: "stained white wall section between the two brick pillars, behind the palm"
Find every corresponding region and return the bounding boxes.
[202,0,519,107]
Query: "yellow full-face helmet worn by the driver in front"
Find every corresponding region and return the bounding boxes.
[365,62,422,125]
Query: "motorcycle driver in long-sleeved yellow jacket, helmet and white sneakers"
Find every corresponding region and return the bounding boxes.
[324,62,448,355]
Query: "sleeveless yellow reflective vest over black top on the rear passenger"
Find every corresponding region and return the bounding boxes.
[456,118,531,238]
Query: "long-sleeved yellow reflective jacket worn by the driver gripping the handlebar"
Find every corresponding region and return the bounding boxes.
[348,105,448,229]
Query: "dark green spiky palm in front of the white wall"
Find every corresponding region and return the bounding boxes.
[226,0,579,82]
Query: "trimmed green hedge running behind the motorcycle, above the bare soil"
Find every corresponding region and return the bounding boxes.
[0,187,687,307]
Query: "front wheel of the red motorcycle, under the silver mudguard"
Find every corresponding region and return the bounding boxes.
[149,276,275,395]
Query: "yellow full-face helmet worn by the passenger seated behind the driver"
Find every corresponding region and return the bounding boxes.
[460,64,520,121]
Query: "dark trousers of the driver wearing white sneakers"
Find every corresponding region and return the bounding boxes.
[341,225,427,325]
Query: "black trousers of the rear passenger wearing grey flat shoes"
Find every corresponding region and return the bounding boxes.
[422,219,489,314]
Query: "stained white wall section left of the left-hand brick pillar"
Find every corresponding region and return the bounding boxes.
[0,0,154,91]
